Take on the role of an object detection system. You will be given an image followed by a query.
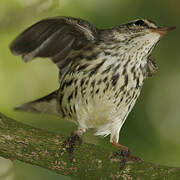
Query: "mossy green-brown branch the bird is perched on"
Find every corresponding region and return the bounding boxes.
[0,114,180,180]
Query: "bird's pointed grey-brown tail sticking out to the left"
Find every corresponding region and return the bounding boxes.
[14,90,58,114]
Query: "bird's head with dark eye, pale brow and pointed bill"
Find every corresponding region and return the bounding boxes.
[116,19,175,54]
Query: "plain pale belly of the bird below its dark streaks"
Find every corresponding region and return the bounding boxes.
[76,87,139,136]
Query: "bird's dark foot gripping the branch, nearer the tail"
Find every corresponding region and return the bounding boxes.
[62,131,82,161]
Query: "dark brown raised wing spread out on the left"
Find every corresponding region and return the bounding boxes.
[10,17,98,78]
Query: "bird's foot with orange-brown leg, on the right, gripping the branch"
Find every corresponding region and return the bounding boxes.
[111,143,142,170]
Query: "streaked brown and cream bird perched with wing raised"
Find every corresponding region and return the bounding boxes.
[10,16,174,158]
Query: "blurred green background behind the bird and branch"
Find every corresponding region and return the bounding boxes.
[0,0,180,180]
